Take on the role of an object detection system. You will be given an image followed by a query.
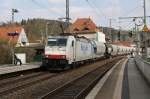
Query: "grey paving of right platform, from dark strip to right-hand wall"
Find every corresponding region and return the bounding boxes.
[122,58,150,99]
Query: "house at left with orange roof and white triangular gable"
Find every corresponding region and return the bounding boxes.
[0,26,29,47]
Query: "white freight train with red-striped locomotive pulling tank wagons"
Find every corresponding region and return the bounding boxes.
[41,36,133,69]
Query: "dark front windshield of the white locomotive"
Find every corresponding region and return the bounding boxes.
[48,38,67,46]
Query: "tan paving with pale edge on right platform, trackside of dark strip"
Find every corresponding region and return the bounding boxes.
[86,59,127,99]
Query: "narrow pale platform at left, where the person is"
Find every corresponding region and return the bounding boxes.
[0,63,41,75]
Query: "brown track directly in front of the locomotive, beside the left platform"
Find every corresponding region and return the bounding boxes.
[0,72,57,97]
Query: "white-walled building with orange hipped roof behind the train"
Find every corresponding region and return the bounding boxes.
[65,18,106,42]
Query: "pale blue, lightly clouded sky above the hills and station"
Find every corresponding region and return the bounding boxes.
[0,0,150,29]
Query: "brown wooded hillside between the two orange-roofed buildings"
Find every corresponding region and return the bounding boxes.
[20,19,66,42]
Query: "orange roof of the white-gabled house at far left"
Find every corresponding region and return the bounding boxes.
[0,26,22,43]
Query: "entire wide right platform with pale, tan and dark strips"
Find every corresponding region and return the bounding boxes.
[86,57,150,99]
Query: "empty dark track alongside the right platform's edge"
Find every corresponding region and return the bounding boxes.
[39,60,118,99]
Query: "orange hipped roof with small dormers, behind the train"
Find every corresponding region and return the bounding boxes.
[66,18,97,33]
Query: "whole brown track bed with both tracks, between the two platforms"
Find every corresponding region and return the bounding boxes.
[0,57,123,99]
